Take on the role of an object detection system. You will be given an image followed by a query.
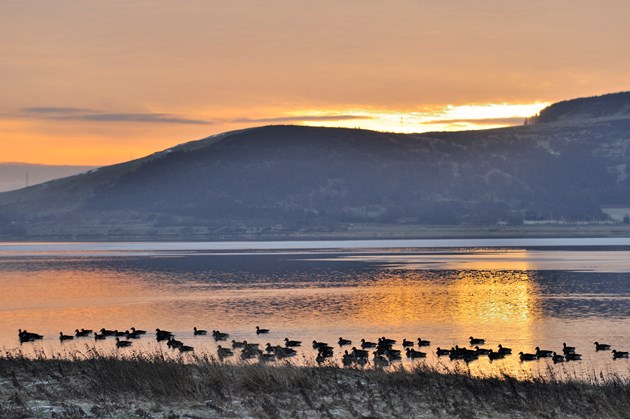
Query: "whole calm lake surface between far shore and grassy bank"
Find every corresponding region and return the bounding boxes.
[0,239,630,377]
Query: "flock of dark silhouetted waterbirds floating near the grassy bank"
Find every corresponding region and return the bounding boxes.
[18,326,628,366]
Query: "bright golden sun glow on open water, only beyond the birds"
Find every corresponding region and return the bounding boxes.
[354,270,540,327]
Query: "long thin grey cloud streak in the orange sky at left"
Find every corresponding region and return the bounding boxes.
[21,106,210,124]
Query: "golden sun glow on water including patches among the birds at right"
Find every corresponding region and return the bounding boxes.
[350,270,546,375]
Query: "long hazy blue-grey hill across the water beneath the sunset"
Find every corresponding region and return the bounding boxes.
[0,93,630,239]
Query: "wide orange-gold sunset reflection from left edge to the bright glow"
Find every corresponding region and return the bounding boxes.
[0,255,628,382]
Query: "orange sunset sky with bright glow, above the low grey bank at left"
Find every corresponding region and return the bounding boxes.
[0,0,630,165]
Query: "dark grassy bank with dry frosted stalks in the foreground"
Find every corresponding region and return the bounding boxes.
[0,354,630,418]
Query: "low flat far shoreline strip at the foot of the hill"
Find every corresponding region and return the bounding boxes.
[0,224,630,242]
